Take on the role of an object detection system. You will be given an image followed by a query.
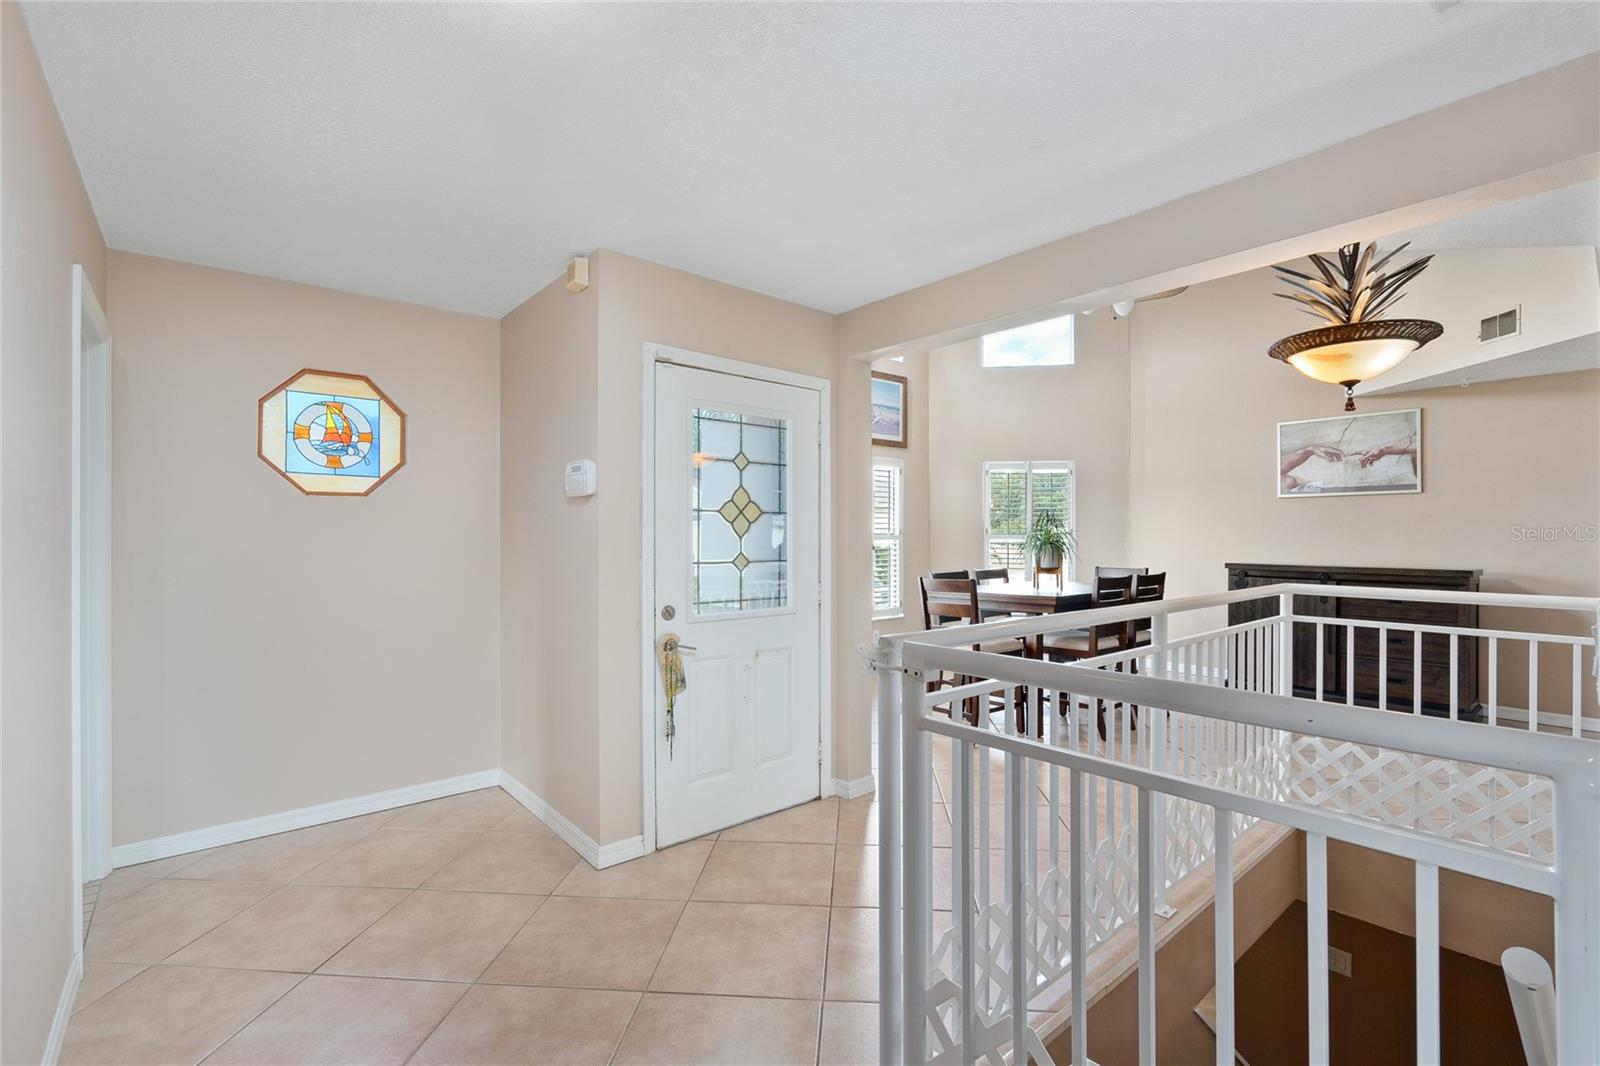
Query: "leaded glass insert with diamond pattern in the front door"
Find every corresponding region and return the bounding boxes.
[690,408,789,615]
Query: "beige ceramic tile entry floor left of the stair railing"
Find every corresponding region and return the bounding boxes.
[61,789,928,1064]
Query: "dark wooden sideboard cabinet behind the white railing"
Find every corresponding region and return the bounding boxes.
[1227,563,1483,719]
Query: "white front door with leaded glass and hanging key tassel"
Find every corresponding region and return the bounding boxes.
[646,363,821,847]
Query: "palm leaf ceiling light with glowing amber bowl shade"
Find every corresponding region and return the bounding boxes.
[1267,242,1445,411]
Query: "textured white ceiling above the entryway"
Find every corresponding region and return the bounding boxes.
[26,3,1600,315]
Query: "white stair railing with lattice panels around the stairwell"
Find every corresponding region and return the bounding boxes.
[877,586,1600,1063]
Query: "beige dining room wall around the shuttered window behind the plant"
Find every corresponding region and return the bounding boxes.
[928,304,1142,575]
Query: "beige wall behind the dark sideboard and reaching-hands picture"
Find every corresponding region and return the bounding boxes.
[1130,267,1600,712]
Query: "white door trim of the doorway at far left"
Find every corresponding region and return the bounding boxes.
[72,264,112,928]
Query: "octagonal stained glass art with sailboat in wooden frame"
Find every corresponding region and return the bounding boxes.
[258,370,405,496]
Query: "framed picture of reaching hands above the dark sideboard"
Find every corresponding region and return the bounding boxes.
[1278,407,1422,496]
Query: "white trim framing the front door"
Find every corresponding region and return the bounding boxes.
[638,343,834,855]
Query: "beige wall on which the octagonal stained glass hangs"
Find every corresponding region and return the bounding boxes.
[110,251,499,844]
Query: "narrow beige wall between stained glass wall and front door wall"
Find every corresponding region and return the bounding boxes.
[499,261,601,836]
